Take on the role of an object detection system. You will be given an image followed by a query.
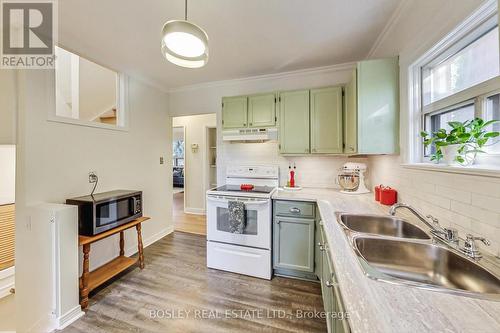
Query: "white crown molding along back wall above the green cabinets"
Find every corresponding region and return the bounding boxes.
[168,62,356,93]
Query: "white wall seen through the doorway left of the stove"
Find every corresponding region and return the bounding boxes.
[172,114,216,214]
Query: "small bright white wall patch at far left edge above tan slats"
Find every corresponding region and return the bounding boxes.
[0,145,16,205]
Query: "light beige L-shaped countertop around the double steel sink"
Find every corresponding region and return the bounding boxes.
[273,188,500,333]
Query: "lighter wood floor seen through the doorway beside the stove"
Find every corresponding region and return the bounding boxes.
[173,192,207,235]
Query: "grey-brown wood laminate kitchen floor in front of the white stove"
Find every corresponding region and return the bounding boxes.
[63,232,326,333]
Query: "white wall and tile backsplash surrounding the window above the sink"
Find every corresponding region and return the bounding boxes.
[369,0,500,254]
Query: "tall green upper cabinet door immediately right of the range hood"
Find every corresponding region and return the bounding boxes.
[279,90,310,154]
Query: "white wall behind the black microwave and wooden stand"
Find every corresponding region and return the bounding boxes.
[16,70,173,330]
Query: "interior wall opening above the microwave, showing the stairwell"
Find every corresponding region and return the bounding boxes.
[52,47,125,128]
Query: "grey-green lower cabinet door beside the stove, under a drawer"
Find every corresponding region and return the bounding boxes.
[273,216,314,273]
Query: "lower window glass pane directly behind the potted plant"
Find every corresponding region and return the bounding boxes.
[425,104,475,156]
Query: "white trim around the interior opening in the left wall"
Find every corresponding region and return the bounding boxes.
[46,44,129,131]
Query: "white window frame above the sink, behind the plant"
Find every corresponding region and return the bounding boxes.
[410,0,500,165]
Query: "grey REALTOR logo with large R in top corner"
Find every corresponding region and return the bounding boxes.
[0,0,57,69]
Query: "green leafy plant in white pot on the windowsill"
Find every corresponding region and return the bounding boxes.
[420,118,500,165]
